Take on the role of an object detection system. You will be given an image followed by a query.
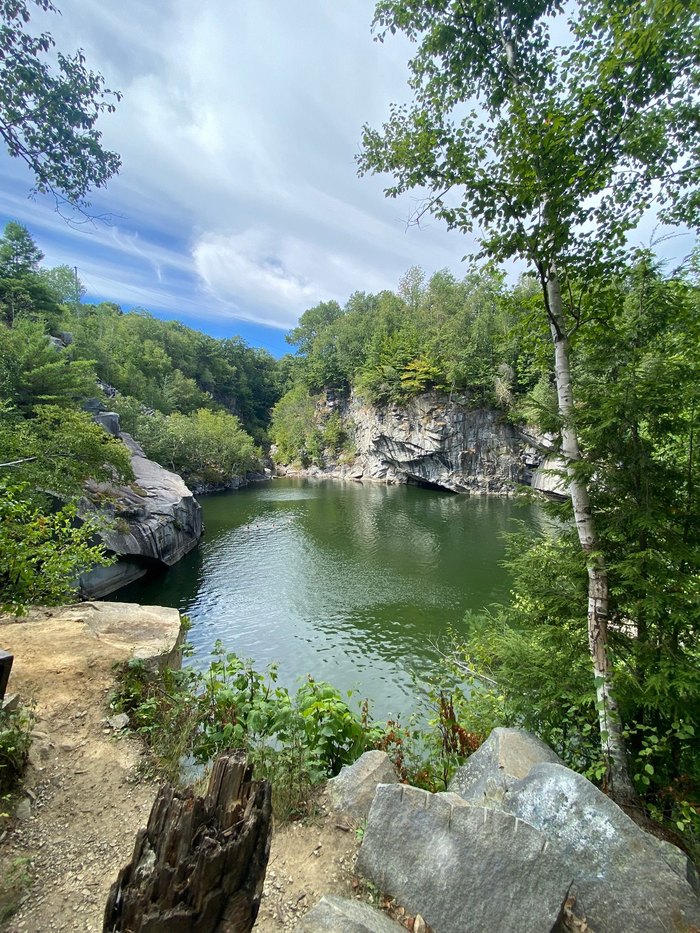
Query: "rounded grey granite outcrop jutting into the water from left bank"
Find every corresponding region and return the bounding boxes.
[80,420,202,598]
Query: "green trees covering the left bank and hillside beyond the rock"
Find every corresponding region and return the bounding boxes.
[0,222,280,608]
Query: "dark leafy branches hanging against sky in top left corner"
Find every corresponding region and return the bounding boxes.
[0,0,120,206]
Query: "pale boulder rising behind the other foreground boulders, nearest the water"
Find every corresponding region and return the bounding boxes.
[447,728,563,808]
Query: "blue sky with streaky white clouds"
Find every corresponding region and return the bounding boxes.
[0,0,482,355]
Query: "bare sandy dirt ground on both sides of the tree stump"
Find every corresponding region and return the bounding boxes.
[0,608,359,933]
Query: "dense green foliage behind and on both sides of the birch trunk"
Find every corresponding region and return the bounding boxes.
[426,262,700,832]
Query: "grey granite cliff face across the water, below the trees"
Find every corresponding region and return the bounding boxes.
[348,392,537,495]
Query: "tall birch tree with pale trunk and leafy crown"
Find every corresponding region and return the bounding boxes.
[358,0,700,803]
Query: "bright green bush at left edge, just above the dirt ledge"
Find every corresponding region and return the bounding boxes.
[0,481,112,612]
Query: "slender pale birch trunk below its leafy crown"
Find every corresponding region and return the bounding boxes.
[546,264,636,805]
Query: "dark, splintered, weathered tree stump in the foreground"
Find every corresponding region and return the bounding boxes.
[103,751,272,933]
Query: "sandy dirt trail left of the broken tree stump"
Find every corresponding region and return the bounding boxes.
[0,608,155,933]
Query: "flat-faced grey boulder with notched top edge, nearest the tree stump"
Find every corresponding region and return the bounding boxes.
[357,784,573,933]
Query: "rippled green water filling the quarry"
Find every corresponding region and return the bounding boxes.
[114,479,541,718]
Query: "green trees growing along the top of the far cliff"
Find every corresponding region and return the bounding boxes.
[278,267,547,416]
